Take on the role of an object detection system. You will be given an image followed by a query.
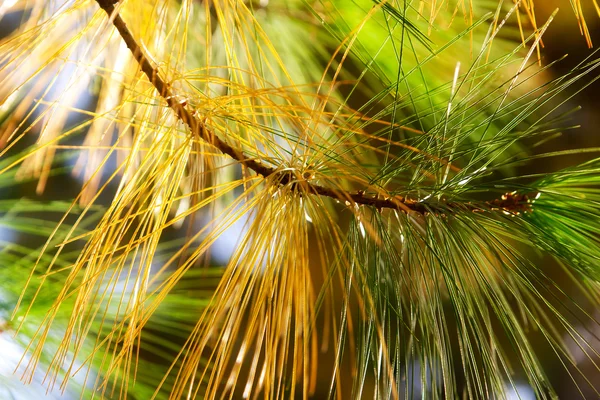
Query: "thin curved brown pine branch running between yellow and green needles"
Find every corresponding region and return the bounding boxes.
[96,0,531,214]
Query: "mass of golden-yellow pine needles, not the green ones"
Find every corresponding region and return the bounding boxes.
[0,0,600,398]
